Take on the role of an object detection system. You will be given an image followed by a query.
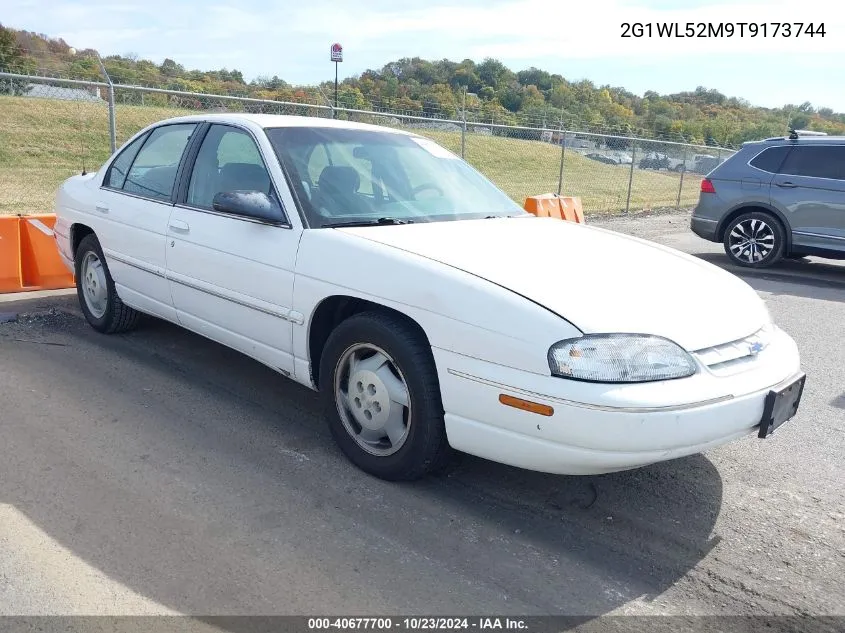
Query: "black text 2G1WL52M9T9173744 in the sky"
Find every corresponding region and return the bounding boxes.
[621,22,825,38]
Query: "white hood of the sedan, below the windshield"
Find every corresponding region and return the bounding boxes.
[338,217,769,351]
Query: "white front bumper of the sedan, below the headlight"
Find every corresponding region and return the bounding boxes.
[435,330,800,475]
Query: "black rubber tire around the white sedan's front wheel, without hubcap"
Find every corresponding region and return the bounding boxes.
[320,312,451,481]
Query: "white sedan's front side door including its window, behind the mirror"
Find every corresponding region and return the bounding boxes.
[167,124,301,374]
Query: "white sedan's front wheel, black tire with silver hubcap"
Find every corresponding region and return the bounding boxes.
[320,312,449,481]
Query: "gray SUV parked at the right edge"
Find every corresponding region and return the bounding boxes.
[690,132,845,268]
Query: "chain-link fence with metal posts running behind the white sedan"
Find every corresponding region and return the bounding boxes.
[0,72,733,214]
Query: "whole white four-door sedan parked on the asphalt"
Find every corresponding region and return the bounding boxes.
[55,114,805,480]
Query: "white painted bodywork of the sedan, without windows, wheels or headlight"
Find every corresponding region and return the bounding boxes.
[56,114,800,474]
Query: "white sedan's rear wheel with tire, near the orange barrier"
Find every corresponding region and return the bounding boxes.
[75,234,140,334]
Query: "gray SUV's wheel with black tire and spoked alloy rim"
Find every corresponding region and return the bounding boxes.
[722,211,786,268]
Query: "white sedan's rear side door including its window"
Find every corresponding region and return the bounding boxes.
[95,123,197,320]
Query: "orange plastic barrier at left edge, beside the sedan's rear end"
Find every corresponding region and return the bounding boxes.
[0,214,74,292]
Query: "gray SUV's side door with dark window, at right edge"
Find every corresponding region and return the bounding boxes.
[771,143,845,250]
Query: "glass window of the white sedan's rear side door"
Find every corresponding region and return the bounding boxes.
[123,123,196,200]
